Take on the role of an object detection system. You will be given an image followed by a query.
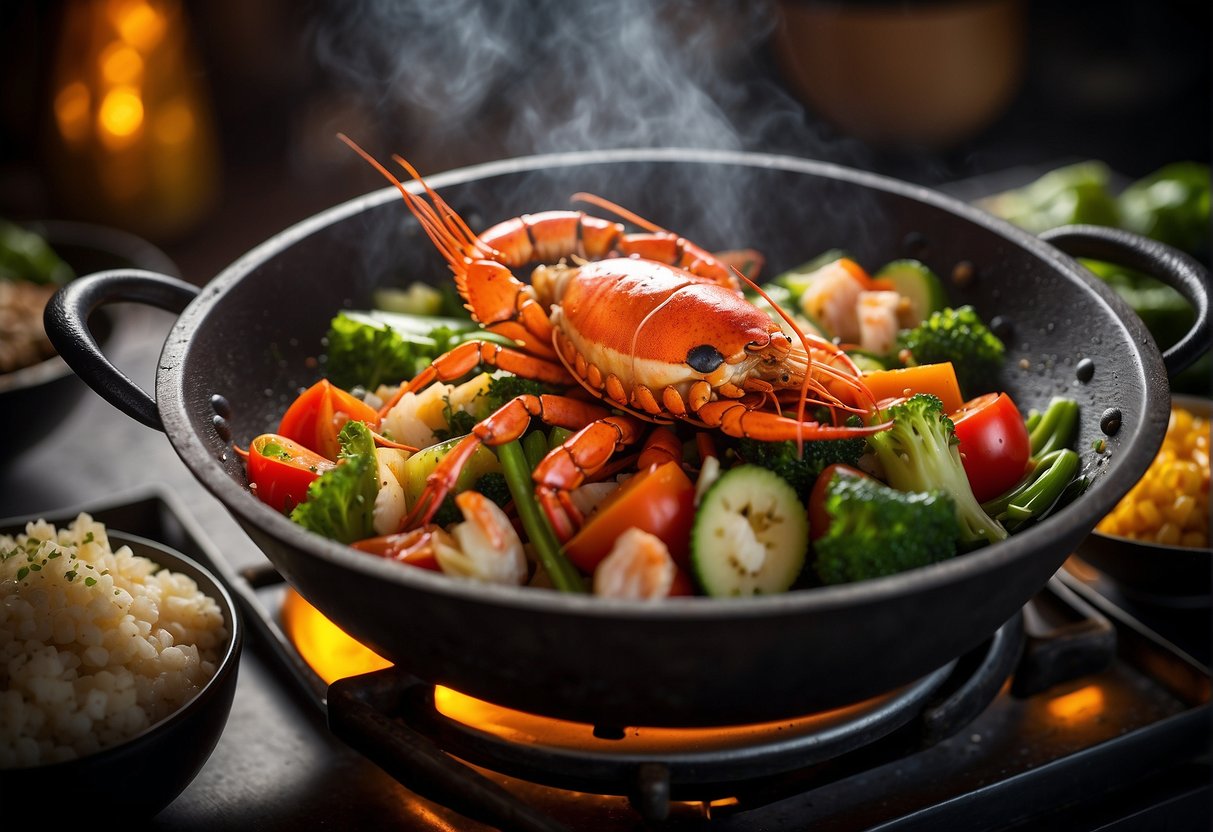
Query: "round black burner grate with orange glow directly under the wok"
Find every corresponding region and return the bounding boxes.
[329,614,1024,820]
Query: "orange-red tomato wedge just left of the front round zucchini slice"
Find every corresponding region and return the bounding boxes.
[564,461,695,574]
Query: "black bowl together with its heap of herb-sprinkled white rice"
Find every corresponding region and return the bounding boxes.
[0,513,244,817]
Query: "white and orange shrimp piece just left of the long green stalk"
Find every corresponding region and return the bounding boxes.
[434,491,529,586]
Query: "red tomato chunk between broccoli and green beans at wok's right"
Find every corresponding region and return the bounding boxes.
[951,393,1032,502]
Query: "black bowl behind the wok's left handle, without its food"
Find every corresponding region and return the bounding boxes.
[0,221,177,465]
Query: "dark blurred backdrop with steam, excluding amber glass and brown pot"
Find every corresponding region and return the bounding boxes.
[0,0,1211,283]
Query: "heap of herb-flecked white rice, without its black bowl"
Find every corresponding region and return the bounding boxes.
[0,514,228,769]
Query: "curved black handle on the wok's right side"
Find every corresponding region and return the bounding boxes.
[1040,226,1213,377]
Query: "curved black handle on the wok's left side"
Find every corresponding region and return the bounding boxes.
[42,269,199,432]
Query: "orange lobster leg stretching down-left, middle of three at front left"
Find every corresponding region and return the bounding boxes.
[404,394,607,530]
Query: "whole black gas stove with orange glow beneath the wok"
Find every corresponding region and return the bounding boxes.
[229,560,1211,832]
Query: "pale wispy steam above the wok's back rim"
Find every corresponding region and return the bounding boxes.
[305,0,834,164]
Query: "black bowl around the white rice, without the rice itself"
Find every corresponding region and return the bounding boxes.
[0,518,244,822]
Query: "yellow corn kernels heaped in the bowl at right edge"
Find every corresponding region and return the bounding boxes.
[1097,405,1209,548]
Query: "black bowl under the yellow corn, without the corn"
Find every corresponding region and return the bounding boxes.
[1077,394,1213,606]
